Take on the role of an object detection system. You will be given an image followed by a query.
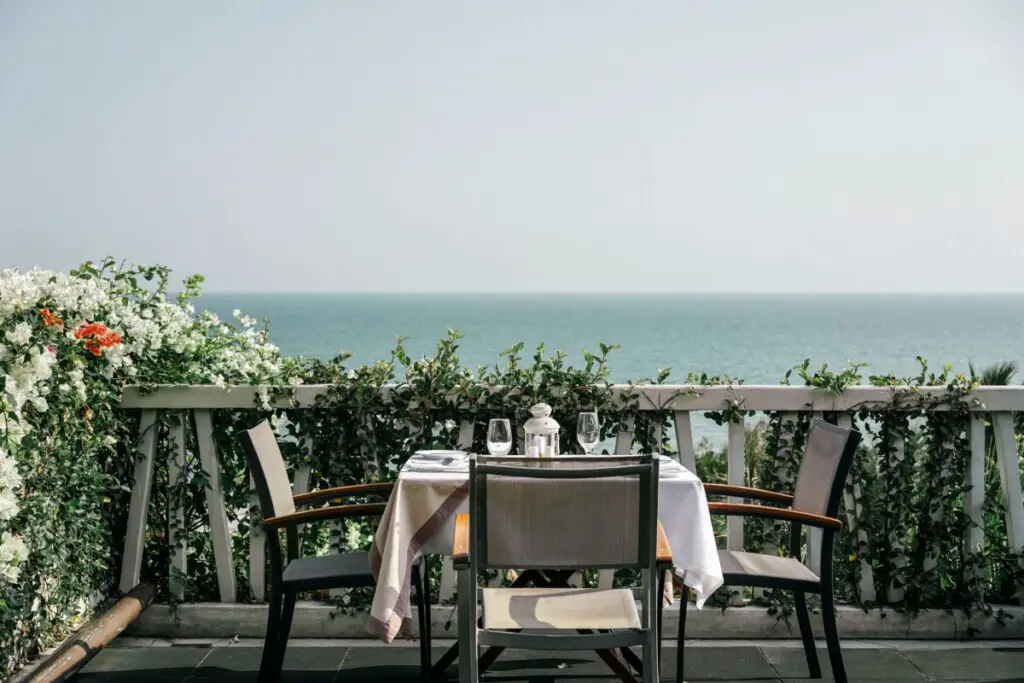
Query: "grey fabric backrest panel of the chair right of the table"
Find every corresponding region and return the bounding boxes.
[793,420,860,517]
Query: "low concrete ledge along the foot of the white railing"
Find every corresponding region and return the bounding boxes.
[124,601,1024,640]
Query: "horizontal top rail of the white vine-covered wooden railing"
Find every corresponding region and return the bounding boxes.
[121,384,1024,413]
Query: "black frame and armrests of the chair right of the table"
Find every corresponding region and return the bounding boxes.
[676,420,860,683]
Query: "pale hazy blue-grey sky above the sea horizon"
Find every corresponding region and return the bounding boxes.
[0,0,1024,292]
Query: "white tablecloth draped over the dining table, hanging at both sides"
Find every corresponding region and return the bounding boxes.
[367,461,722,642]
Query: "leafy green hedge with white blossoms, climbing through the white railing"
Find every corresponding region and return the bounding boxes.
[0,260,1021,673]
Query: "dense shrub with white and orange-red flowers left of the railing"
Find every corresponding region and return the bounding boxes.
[0,260,294,678]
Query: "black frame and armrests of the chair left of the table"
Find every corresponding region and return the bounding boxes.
[239,421,431,683]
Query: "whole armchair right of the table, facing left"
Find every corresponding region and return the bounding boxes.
[676,420,860,683]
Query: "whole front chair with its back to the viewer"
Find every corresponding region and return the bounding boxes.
[454,456,671,683]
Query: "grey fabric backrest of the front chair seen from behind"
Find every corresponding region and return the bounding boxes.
[470,456,657,569]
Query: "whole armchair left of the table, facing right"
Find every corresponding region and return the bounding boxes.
[239,420,430,683]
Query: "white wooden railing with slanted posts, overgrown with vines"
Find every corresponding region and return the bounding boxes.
[114,385,1024,602]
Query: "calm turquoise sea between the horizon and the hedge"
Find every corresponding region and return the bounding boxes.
[199,293,1024,384]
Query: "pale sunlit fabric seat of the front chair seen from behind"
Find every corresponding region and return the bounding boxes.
[482,588,640,630]
